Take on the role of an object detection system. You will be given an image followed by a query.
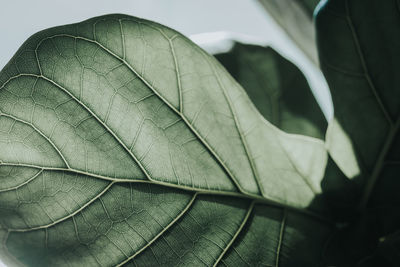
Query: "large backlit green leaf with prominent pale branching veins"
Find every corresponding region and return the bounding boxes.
[0,15,332,266]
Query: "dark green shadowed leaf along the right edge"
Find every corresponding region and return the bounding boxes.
[317,0,400,214]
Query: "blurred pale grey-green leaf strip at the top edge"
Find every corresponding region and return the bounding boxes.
[259,0,318,65]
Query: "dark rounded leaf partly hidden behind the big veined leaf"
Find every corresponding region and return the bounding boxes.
[214,43,327,139]
